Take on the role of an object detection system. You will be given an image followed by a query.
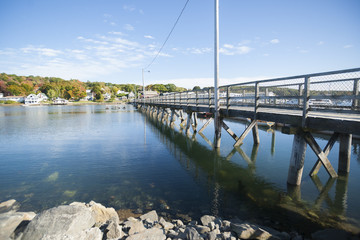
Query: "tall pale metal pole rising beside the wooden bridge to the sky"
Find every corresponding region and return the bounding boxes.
[214,0,221,148]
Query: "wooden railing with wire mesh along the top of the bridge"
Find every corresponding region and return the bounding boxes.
[140,68,360,118]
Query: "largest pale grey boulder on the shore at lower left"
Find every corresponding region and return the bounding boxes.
[22,206,96,240]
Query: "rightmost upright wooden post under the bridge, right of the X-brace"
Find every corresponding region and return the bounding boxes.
[338,134,352,173]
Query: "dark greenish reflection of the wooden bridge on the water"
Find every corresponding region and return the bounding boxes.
[144,112,360,233]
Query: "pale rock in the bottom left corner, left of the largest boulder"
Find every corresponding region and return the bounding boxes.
[0,212,36,239]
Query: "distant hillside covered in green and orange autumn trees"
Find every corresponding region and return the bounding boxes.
[0,73,186,100]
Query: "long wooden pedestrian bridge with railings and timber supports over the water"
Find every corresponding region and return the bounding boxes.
[134,68,360,185]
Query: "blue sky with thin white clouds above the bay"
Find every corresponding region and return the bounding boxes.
[0,0,360,88]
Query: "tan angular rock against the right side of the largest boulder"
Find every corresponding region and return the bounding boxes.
[88,201,119,226]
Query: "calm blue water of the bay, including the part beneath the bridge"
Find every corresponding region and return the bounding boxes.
[0,105,360,232]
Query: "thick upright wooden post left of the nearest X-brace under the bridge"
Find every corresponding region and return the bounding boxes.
[287,134,307,185]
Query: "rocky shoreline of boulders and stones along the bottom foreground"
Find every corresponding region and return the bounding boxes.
[0,199,360,240]
